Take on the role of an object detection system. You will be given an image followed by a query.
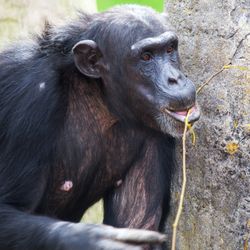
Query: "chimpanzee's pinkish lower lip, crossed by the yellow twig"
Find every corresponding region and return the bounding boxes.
[164,105,200,123]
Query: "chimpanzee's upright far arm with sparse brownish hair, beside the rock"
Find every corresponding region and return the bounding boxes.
[104,136,174,244]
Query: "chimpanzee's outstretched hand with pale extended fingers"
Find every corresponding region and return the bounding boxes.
[56,223,166,250]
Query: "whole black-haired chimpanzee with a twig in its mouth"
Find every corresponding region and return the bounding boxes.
[0,5,199,250]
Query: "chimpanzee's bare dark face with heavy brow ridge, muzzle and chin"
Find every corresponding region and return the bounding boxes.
[120,31,200,136]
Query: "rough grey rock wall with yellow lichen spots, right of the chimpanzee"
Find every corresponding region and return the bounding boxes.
[165,0,250,250]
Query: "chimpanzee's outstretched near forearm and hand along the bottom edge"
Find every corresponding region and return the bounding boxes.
[0,204,167,250]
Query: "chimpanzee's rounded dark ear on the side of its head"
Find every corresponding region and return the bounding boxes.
[72,40,102,78]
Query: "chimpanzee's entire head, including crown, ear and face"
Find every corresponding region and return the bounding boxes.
[73,5,200,136]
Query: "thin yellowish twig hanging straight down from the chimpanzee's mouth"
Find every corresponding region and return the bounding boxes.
[171,110,190,250]
